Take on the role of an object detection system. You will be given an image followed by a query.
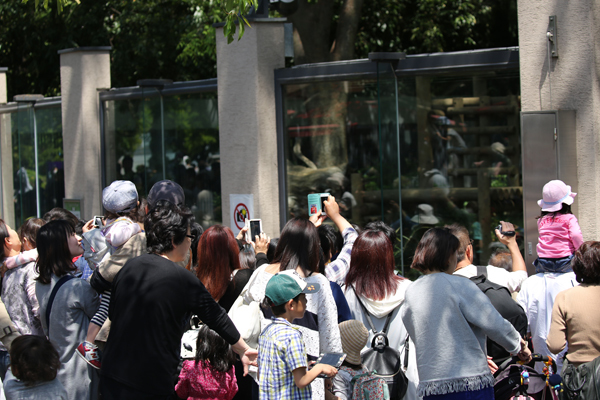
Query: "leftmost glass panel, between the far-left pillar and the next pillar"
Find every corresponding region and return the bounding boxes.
[11,104,65,228]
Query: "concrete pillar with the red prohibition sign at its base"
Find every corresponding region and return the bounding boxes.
[216,18,285,237]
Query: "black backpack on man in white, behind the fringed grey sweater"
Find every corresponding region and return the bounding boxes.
[470,266,527,365]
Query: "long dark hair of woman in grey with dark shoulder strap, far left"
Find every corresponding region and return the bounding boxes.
[36,220,77,284]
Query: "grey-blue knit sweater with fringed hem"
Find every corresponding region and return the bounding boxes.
[401,273,520,396]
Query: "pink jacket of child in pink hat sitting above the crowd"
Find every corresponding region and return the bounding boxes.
[536,214,583,258]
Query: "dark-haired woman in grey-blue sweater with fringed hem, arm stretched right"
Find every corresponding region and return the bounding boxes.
[401,228,531,400]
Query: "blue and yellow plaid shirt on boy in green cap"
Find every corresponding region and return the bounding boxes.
[258,318,312,400]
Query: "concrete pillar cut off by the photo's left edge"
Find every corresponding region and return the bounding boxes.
[0,68,15,228]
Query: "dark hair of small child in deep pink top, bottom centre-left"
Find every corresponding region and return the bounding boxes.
[195,325,235,372]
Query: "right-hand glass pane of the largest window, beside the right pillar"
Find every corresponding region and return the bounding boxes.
[400,71,523,276]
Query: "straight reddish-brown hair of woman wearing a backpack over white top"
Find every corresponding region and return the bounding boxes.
[346,230,403,300]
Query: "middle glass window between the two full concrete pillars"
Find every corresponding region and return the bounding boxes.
[104,89,222,227]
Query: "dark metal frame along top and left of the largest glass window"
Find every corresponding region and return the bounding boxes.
[274,47,519,229]
